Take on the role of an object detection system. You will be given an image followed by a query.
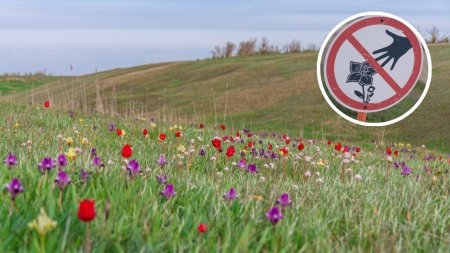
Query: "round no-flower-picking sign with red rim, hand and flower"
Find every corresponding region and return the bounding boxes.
[318,12,431,126]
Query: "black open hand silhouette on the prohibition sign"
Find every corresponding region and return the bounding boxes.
[373,30,412,70]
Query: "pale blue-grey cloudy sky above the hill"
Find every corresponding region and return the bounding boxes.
[0,0,450,75]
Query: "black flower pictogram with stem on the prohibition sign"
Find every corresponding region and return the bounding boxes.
[347,61,377,104]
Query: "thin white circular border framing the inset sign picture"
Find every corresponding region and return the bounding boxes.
[317,11,432,126]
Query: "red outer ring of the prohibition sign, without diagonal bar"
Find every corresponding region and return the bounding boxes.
[325,16,422,112]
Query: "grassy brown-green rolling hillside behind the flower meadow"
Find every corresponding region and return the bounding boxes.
[3,44,450,152]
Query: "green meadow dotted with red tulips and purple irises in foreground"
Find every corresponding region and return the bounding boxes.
[0,104,450,252]
